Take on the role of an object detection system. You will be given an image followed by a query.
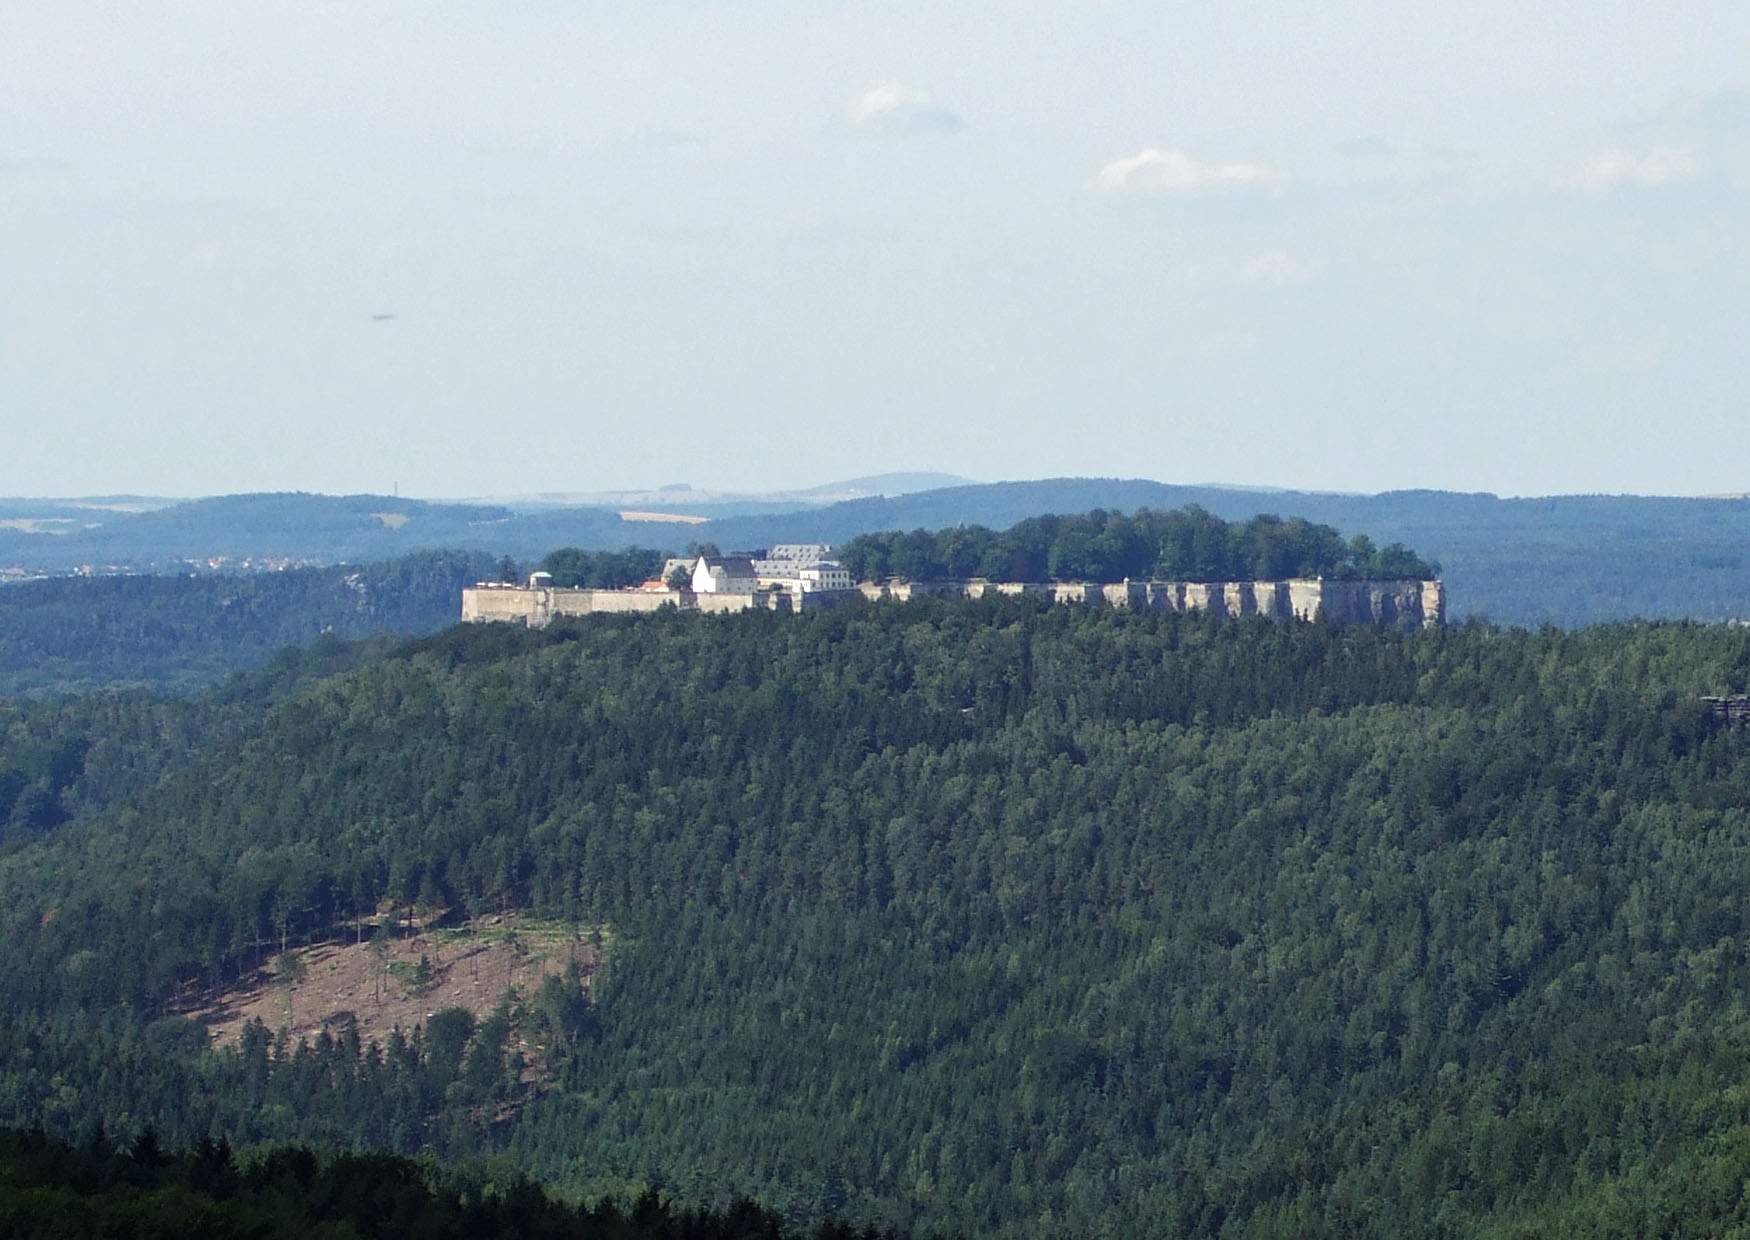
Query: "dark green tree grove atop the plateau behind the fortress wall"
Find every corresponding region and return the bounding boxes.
[838,505,1440,581]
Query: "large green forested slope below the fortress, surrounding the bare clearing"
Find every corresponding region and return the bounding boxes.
[0,600,1750,1237]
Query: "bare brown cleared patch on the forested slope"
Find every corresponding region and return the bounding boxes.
[187,915,602,1046]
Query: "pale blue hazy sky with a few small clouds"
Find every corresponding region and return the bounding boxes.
[0,0,1750,497]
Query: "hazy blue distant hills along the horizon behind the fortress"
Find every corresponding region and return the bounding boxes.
[10,476,1750,626]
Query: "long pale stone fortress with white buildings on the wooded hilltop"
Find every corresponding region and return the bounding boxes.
[462,556,1446,628]
